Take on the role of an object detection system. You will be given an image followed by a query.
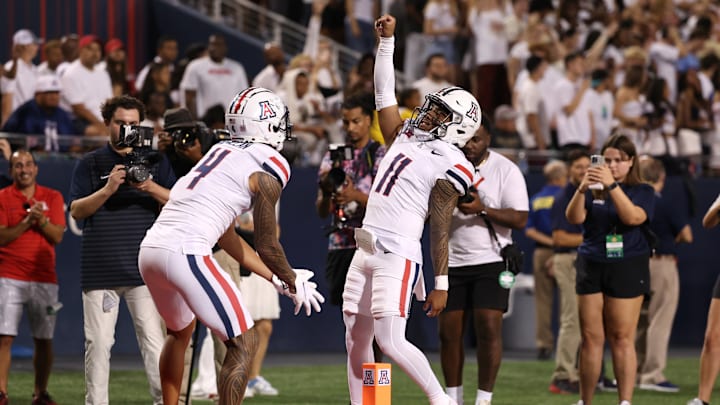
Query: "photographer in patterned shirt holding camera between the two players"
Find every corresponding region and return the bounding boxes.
[316,93,385,306]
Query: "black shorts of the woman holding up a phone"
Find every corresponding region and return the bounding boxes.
[575,255,650,298]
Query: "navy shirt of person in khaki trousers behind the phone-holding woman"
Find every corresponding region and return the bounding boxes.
[650,193,690,255]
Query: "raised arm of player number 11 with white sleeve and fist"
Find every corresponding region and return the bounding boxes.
[374,14,402,147]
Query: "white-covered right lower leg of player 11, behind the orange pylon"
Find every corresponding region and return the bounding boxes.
[374,316,447,405]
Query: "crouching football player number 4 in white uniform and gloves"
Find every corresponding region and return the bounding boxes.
[138,87,324,405]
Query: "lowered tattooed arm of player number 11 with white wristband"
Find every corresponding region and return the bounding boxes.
[423,180,459,317]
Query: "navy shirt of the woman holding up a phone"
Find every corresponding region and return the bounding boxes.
[578,184,655,263]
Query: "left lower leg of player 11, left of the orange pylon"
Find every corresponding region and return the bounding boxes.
[343,313,375,405]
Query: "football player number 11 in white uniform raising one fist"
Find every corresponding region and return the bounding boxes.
[343,15,480,405]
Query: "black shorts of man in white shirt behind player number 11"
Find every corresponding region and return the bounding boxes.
[445,262,510,312]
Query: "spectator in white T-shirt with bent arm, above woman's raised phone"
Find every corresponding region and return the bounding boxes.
[553,52,595,150]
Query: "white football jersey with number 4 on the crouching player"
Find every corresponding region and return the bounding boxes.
[141,142,290,255]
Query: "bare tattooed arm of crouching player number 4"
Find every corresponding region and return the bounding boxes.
[250,172,295,293]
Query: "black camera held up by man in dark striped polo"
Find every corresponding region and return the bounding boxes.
[117,125,160,183]
